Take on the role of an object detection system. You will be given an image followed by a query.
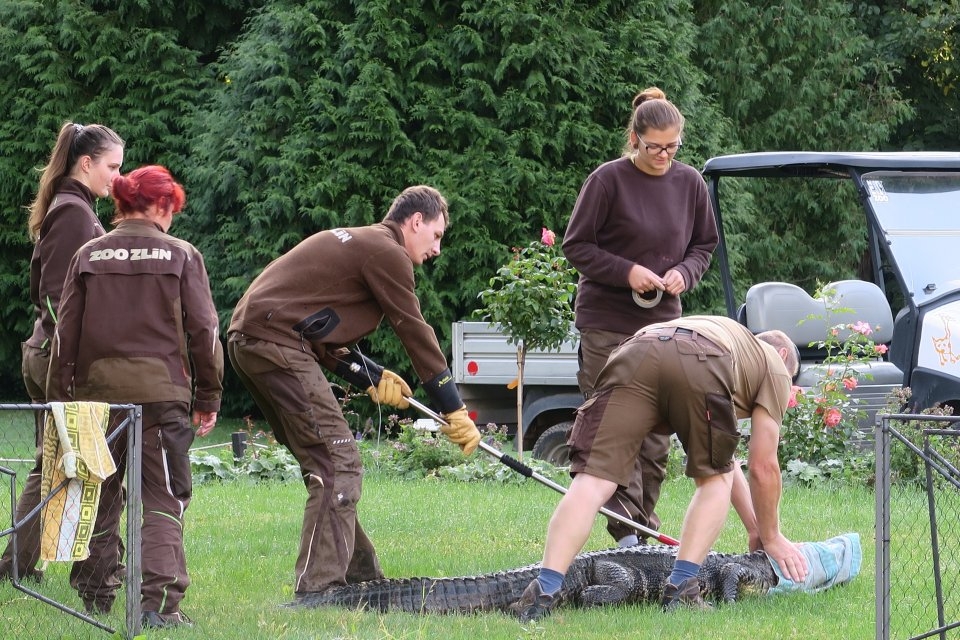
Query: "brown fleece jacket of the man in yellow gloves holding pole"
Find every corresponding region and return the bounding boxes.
[228,222,447,382]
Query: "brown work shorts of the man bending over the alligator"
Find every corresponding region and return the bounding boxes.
[570,327,740,487]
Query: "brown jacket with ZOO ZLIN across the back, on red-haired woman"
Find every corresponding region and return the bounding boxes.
[47,219,223,411]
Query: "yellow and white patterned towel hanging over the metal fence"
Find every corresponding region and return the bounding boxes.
[40,402,117,561]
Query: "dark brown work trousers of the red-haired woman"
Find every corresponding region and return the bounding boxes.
[70,402,195,615]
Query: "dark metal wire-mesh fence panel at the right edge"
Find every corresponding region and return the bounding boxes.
[875,414,960,640]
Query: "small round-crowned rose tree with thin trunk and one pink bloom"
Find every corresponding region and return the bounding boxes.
[476,227,577,459]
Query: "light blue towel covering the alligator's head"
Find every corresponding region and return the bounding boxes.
[768,533,863,594]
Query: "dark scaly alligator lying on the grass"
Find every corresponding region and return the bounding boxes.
[292,544,779,614]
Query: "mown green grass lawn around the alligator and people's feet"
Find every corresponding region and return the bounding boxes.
[0,424,875,640]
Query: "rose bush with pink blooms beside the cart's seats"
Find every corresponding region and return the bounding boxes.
[779,321,887,481]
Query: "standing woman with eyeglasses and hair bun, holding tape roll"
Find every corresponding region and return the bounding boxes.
[563,87,718,546]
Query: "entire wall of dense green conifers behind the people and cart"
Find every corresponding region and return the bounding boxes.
[0,0,948,414]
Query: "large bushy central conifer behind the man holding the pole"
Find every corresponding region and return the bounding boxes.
[178,0,736,412]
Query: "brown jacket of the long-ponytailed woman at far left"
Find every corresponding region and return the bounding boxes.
[27,178,104,349]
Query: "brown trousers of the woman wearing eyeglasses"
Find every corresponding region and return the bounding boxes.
[577,329,670,540]
